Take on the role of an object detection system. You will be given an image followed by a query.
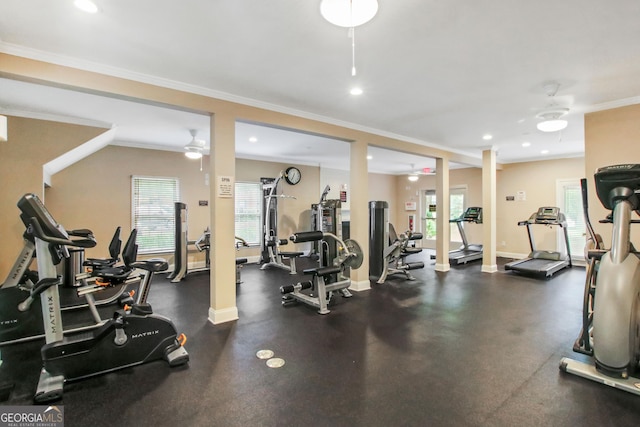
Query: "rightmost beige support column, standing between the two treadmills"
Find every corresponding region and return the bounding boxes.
[482,148,498,273]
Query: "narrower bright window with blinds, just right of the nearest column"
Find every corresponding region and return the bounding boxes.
[235,182,262,245]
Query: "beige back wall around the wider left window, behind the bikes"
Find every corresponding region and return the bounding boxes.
[47,146,215,268]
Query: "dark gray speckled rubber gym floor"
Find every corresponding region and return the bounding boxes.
[0,253,640,426]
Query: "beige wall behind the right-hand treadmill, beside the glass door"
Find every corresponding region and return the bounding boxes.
[496,158,584,255]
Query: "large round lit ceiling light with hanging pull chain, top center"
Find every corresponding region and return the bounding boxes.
[320,0,378,76]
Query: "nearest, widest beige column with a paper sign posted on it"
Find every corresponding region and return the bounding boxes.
[209,113,238,325]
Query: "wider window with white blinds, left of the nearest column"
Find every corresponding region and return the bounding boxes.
[131,176,180,253]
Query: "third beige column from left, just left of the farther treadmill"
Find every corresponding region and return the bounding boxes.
[435,158,451,271]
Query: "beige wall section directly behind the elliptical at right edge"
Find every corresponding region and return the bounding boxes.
[584,105,640,247]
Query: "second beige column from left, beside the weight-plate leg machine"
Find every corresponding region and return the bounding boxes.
[349,141,371,291]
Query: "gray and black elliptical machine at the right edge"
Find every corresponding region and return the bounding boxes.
[560,164,640,395]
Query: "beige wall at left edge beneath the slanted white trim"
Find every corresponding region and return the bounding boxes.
[0,117,104,281]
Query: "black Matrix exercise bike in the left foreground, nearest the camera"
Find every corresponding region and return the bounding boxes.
[18,194,189,403]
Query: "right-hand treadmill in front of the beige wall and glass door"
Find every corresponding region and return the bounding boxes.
[504,206,573,279]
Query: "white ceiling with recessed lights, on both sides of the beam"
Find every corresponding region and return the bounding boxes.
[0,0,640,173]
